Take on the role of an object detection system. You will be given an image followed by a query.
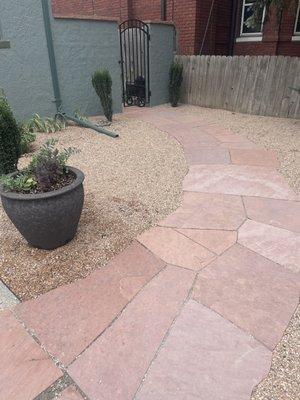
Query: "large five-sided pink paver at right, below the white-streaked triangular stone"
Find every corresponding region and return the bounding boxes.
[193,245,300,349]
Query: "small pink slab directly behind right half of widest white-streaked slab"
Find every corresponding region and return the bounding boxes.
[230,149,279,168]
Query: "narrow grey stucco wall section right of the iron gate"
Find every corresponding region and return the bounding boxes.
[149,24,175,107]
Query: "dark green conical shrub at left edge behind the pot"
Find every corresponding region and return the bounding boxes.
[0,94,21,175]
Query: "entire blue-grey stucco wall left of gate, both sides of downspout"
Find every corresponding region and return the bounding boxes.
[0,0,122,119]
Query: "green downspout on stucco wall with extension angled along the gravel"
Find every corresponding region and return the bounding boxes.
[41,0,119,138]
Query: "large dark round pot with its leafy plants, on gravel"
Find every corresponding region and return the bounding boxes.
[0,139,84,250]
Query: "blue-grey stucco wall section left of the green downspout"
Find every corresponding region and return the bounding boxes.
[0,0,55,118]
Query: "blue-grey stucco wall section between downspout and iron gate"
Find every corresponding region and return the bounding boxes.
[52,19,122,115]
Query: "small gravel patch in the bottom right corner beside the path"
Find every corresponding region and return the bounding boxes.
[251,306,300,400]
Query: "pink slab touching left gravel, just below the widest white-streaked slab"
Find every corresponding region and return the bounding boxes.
[159,192,246,230]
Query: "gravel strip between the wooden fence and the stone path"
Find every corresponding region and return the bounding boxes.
[178,105,300,193]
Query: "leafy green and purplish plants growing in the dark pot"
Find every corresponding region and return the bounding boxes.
[1,139,78,193]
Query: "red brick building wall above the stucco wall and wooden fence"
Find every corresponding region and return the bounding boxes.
[52,0,300,56]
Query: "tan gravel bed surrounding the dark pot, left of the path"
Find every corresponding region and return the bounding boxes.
[0,116,187,300]
